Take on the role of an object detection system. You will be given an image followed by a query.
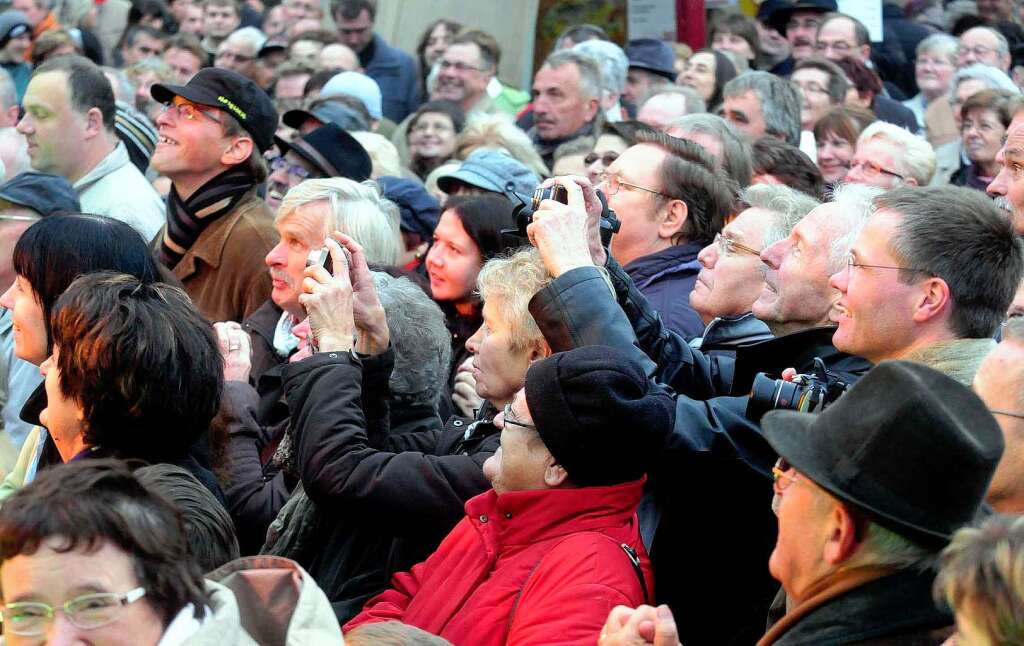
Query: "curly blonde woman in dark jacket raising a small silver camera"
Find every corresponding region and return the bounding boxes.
[260,238,550,619]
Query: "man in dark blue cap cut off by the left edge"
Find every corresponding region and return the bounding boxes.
[0,171,81,473]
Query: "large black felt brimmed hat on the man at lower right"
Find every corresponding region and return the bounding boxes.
[761,361,1004,546]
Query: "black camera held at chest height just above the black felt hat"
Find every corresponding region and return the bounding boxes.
[746,357,848,422]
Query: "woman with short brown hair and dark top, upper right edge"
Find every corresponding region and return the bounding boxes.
[949,90,1014,190]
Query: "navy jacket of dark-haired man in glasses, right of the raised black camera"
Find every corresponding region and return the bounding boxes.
[625,244,705,341]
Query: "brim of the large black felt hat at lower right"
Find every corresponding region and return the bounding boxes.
[761,411,951,546]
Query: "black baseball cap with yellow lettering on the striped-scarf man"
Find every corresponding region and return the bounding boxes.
[150,68,278,153]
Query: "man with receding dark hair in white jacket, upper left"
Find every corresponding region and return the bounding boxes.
[17,56,164,241]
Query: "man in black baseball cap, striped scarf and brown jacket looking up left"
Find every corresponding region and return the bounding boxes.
[151,68,278,321]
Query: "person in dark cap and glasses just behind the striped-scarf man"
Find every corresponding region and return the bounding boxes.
[266,123,373,211]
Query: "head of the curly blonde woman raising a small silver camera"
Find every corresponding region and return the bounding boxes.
[476,249,552,350]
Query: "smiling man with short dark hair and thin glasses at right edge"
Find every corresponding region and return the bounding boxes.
[831,186,1024,384]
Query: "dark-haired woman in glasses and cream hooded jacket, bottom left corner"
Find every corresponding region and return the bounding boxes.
[0,460,341,646]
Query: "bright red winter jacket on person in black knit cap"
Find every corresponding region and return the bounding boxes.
[345,479,653,646]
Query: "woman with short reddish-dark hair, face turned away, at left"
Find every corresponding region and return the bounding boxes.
[5,271,222,499]
